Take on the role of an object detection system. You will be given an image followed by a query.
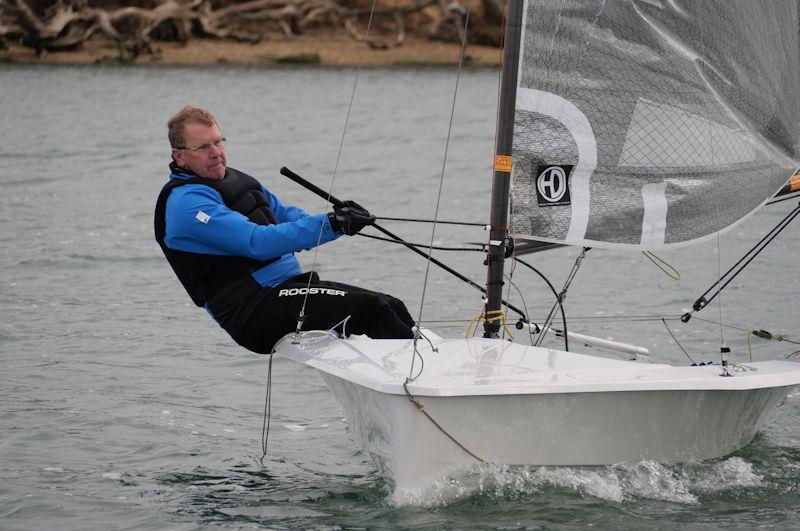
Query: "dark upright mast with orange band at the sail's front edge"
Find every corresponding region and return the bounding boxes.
[483,0,524,337]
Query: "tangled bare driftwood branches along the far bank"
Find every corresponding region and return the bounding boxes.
[0,0,504,58]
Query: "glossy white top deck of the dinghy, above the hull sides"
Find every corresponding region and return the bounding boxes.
[276,332,800,396]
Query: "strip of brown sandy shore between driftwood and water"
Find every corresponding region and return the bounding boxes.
[0,36,501,67]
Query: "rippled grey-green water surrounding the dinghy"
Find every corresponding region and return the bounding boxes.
[0,66,800,529]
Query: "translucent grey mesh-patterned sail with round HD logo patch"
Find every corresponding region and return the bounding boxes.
[510,0,800,249]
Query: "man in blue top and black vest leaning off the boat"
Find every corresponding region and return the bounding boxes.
[155,106,414,354]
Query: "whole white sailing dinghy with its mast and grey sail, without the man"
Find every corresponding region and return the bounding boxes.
[275,0,800,496]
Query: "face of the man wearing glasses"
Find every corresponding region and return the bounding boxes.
[172,122,228,179]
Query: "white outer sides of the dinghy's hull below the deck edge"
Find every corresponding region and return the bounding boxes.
[320,373,791,489]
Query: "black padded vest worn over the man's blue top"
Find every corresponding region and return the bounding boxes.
[154,162,280,306]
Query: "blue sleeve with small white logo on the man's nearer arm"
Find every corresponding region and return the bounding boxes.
[164,184,341,260]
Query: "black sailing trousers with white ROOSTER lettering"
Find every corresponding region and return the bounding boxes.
[234,272,414,354]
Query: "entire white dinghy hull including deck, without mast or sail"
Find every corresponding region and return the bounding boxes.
[278,340,800,489]
